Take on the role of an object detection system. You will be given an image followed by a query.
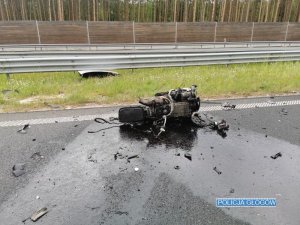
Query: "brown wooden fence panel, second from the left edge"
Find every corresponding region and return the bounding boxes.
[38,22,88,44]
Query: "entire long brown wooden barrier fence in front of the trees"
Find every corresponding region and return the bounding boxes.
[0,21,300,44]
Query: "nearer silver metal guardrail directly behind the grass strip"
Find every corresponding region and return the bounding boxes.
[0,48,300,74]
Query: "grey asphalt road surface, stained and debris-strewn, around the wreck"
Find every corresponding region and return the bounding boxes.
[0,96,300,225]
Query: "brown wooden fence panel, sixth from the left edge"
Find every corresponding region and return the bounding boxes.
[216,23,253,42]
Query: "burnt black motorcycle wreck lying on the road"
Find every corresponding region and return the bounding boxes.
[119,85,229,137]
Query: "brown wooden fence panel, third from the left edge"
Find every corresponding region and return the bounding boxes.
[89,22,134,44]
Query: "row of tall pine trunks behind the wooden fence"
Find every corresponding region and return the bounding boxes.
[0,0,300,22]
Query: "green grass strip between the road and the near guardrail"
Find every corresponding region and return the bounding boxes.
[0,62,300,112]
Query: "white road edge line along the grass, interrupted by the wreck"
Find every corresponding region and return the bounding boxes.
[0,100,300,127]
